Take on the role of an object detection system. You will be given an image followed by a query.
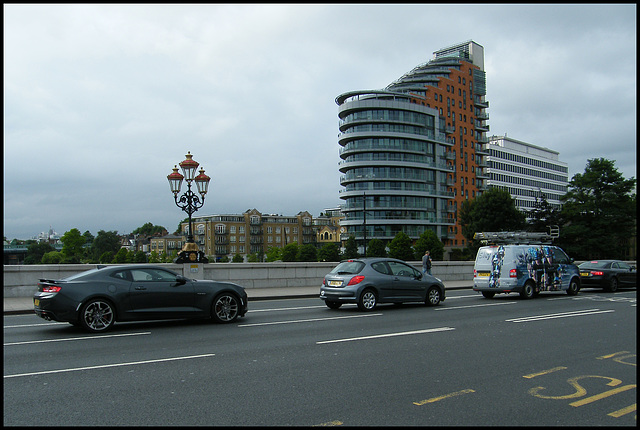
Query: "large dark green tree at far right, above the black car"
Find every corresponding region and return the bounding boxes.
[559,158,637,259]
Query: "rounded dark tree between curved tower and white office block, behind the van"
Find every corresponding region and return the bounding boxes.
[458,188,526,242]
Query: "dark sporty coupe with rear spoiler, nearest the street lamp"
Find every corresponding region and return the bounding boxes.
[33,265,247,332]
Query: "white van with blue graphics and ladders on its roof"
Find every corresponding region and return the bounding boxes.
[473,244,580,299]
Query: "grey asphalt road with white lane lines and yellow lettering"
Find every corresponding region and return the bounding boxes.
[3,289,637,427]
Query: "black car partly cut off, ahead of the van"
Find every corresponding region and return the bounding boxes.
[578,260,637,292]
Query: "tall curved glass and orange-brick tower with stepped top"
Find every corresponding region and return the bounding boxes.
[336,41,488,246]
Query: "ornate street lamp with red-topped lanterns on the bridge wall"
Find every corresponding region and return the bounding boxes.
[167,152,211,263]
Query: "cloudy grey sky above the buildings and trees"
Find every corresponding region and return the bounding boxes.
[4,4,637,239]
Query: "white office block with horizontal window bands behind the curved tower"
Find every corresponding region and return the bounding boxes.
[486,135,569,211]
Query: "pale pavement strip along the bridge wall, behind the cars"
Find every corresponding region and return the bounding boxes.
[4,280,473,315]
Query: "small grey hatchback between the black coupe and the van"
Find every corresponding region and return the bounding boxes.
[320,258,445,311]
